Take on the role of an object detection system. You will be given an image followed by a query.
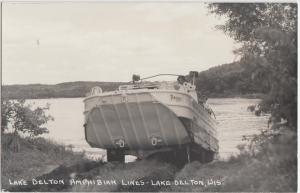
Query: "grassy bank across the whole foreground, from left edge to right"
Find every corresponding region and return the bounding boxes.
[2,130,297,192]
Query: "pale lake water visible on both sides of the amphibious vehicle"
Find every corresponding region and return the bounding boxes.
[28,98,268,160]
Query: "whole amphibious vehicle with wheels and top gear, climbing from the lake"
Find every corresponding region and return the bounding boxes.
[84,71,219,163]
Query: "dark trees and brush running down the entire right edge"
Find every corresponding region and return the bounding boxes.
[209,3,297,191]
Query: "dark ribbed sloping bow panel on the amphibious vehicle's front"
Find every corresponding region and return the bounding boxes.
[85,98,190,150]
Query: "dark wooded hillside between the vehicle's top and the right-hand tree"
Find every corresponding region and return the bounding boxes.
[196,62,269,97]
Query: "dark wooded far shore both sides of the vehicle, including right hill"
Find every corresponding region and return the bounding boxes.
[2,62,266,99]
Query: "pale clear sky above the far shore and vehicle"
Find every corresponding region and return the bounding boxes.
[2,2,237,85]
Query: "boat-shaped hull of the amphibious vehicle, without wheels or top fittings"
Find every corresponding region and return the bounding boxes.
[84,90,218,152]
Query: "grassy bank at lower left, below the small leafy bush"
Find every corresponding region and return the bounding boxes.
[1,134,87,189]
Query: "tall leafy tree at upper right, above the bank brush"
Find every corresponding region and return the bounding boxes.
[209,3,297,131]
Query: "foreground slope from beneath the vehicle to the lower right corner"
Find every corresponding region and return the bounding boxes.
[67,132,297,192]
